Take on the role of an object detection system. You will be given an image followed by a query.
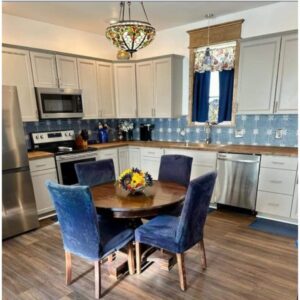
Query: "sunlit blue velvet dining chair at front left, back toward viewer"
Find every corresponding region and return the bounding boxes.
[46,181,134,298]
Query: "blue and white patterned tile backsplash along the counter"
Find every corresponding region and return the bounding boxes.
[23,115,298,148]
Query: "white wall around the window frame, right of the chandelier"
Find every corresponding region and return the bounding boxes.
[136,2,298,114]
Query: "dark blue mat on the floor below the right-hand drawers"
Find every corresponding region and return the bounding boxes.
[249,218,298,240]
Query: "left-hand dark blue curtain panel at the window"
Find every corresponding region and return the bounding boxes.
[192,71,210,122]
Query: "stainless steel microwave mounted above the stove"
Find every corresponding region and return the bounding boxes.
[35,88,83,119]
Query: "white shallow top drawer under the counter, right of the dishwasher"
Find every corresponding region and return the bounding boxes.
[260,155,298,171]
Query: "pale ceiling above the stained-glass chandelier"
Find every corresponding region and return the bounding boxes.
[2,1,274,35]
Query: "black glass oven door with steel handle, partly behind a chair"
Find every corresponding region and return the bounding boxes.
[56,151,97,185]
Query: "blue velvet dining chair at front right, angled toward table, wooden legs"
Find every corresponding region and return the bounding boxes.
[135,172,217,291]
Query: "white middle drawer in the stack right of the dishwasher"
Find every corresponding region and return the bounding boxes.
[258,168,296,195]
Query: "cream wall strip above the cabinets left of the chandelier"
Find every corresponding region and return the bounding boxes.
[2,14,117,59]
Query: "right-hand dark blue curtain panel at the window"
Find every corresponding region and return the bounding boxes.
[218,69,234,123]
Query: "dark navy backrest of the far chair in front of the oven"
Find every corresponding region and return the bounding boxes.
[75,159,116,187]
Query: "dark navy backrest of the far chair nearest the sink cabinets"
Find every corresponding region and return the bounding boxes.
[158,155,193,187]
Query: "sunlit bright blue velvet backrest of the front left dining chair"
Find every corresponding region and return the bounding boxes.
[46,181,102,260]
